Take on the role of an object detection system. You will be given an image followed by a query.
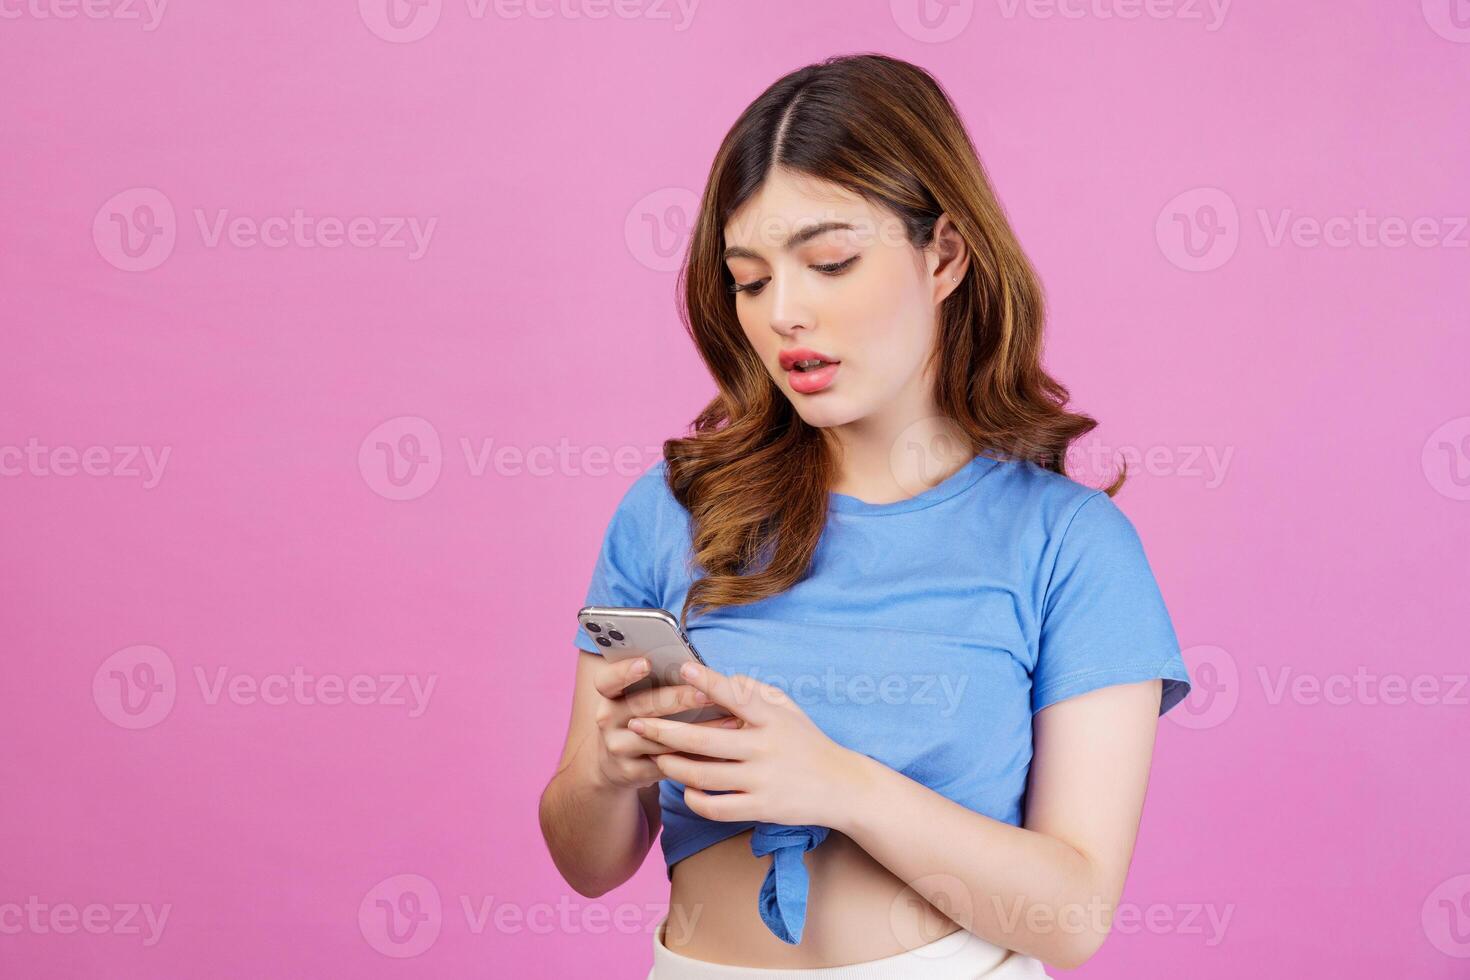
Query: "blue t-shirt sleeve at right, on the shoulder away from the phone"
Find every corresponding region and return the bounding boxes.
[1030,491,1189,714]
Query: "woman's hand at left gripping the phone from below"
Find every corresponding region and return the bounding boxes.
[594,657,739,789]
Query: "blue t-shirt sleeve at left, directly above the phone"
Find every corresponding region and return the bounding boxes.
[576,464,663,654]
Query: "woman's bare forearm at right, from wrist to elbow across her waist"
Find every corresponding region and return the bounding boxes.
[832,752,1117,970]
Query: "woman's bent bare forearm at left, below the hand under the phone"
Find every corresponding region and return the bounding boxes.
[539,739,660,898]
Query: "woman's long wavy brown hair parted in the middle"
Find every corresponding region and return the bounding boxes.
[663,54,1126,623]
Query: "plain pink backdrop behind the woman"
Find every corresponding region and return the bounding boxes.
[0,0,1470,979]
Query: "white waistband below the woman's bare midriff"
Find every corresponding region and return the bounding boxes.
[648,915,1047,980]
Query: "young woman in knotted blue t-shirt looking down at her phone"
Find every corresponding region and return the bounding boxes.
[541,54,1189,980]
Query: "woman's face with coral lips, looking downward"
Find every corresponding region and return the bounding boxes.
[725,167,963,432]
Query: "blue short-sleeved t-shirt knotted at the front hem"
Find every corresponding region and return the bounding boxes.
[576,455,1189,942]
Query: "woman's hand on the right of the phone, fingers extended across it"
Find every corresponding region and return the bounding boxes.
[628,663,870,830]
